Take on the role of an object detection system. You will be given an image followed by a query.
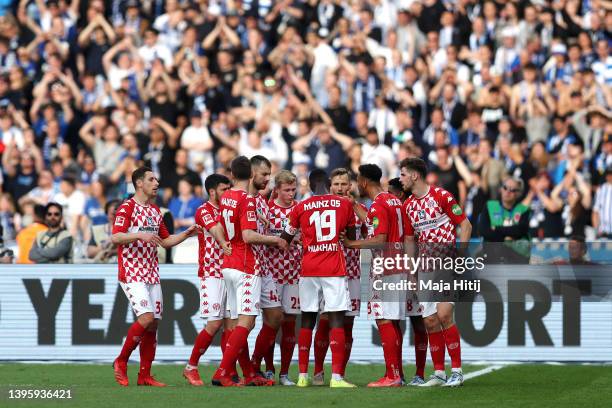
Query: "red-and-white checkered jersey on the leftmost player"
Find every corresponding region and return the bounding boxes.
[113,198,170,284]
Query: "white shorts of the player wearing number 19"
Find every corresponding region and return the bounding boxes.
[299,276,350,313]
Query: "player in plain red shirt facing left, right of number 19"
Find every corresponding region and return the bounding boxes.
[344,164,406,387]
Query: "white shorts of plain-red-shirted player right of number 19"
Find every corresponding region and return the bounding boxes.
[368,273,406,320]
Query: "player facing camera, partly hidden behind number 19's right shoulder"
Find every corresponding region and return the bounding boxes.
[312,168,368,385]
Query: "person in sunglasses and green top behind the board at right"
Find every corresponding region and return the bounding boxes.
[478,177,531,263]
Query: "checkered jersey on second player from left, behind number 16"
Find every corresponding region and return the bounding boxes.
[195,201,223,278]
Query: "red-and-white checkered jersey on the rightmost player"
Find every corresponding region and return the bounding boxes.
[402,186,465,244]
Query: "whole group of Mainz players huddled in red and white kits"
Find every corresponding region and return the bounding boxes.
[112,156,471,388]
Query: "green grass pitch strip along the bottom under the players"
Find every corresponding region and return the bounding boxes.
[0,363,612,408]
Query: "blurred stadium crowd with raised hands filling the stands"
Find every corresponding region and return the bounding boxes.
[0,0,612,262]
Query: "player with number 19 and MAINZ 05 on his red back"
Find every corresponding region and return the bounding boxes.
[282,169,355,388]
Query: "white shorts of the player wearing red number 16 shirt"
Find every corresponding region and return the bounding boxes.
[221,268,261,319]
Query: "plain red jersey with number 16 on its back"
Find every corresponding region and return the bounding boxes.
[219,188,259,275]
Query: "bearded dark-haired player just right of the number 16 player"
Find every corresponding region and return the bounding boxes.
[249,155,283,381]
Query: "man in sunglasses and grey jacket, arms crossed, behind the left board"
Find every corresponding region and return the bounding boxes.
[30,202,73,264]
